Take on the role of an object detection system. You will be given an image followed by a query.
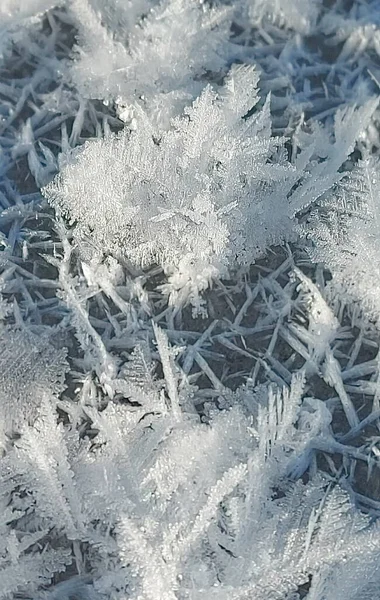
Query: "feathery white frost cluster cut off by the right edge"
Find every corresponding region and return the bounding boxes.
[307,158,380,322]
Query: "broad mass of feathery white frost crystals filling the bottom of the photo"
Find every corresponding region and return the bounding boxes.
[0,366,380,600]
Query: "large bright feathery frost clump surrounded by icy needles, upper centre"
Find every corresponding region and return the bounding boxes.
[44,67,294,310]
